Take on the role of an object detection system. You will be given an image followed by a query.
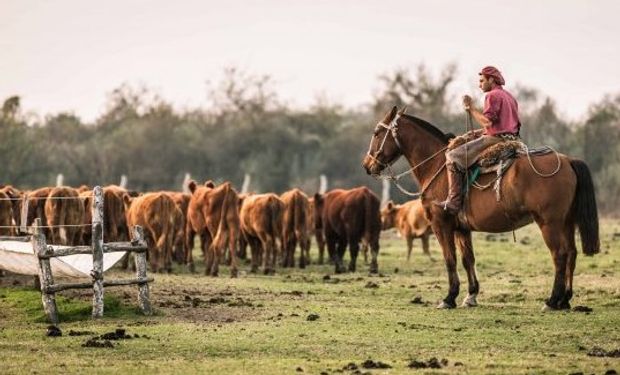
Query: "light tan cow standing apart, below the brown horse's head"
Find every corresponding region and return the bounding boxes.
[381,199,433,261]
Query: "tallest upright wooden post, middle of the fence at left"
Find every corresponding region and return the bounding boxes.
[90,186,103,318]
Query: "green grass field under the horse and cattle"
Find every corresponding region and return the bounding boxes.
[0,221,620,374]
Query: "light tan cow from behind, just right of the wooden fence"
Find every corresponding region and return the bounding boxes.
[124,193,178,272]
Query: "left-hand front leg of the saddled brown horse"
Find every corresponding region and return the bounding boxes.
[433,221,460,309]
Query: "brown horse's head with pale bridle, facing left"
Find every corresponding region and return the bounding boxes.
[362,106,406,175]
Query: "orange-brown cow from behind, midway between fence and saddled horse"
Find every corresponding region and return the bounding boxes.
[239,193,284,275]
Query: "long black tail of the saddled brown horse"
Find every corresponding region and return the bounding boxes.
[570,159,601,255]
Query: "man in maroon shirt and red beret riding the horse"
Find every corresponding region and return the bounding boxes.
[433,66,521,214]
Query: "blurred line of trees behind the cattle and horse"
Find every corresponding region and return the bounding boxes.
[0,65,620,215]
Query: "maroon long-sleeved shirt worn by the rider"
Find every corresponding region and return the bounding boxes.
[482,86,521,135]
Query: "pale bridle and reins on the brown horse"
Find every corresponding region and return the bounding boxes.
[367,113,448,198]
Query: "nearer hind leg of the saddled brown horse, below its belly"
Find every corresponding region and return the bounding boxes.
[539,223,569,310]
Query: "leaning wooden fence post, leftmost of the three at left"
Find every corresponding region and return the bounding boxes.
[32,218,58,324]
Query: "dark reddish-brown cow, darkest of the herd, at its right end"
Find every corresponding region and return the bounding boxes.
[314,187,381,273]
